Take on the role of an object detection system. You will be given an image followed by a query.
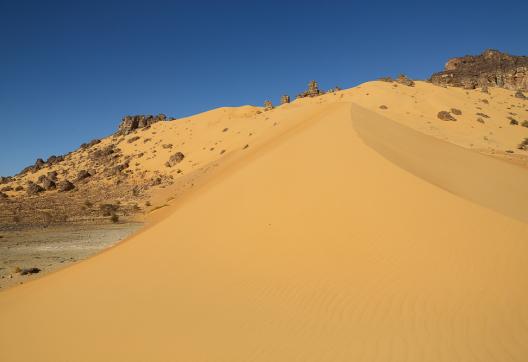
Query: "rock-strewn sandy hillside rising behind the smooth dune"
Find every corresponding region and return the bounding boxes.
[0,73,528,228]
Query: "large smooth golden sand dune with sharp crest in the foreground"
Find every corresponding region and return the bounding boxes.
[0,97,528,362]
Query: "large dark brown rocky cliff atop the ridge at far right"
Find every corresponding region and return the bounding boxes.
[430,49,528,90]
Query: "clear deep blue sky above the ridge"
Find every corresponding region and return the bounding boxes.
[0,0,528,175]
